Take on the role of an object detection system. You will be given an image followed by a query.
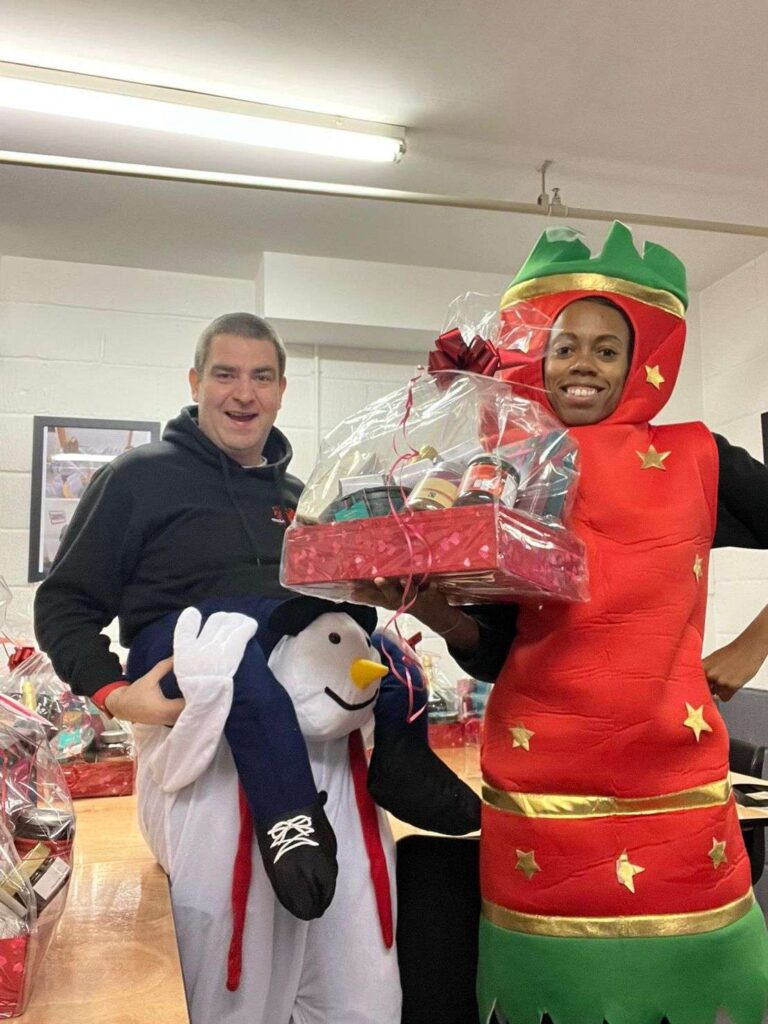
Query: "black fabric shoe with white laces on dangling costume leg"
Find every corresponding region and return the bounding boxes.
[255,793,338,921]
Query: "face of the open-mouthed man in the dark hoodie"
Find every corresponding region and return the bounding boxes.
[189,334,286,466]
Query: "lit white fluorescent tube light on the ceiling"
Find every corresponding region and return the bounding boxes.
[0,61,406,162]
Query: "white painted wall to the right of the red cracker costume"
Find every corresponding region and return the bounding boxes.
[699,253,768,689]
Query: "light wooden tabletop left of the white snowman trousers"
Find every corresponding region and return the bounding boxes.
[16,797,189,1024]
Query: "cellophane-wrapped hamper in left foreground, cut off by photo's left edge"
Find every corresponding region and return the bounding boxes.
[0,695,75,1019]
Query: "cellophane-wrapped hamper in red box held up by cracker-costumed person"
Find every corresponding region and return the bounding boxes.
[281,371,588,604]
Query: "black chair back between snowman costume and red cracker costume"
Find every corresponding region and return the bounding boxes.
[397,836,480,1024]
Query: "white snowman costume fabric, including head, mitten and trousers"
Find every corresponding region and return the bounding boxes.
[136,609,401,1024]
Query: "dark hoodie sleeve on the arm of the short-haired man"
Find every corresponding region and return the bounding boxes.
[35,466,139,695]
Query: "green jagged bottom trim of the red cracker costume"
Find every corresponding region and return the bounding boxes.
[477,904,768,1024]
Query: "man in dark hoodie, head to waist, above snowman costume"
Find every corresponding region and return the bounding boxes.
[35,313,301,725]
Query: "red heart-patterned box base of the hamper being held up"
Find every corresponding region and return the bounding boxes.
[281,504,588,603]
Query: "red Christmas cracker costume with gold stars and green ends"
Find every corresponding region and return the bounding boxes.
[478,224,768,1024]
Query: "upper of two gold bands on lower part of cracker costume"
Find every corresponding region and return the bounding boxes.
[482,778,731,818]
